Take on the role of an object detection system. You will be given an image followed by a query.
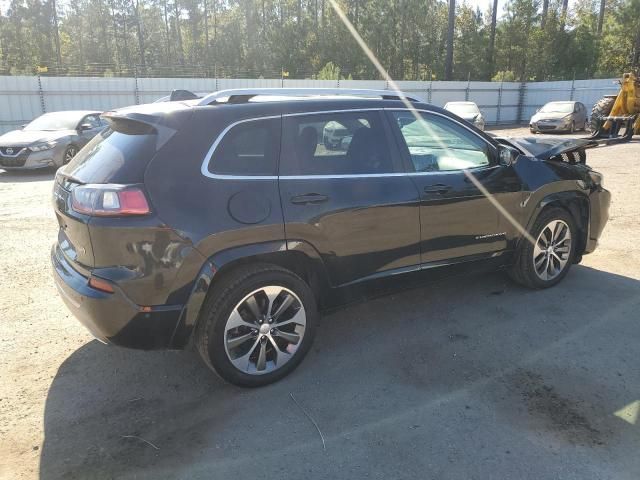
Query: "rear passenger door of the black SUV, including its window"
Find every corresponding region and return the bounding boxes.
[279,109,420,286]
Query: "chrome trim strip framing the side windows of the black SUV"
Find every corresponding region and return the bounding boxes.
[200,107,500,180]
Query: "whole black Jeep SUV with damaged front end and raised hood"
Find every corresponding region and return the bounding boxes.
[51,90,610,386]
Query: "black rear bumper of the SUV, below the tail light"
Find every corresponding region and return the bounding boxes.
[51,244,182,350]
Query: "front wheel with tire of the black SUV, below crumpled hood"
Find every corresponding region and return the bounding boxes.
[509,207,577,288]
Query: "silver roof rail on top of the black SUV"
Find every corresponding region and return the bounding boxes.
[198,88,421,105]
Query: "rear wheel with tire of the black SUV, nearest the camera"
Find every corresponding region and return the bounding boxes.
[195,264,318,387]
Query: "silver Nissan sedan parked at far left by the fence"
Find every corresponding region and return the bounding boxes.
[0,110,106,170]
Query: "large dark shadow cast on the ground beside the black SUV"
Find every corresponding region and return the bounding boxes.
[40,266,640,479]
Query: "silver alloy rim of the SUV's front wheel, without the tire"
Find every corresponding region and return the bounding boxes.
[533,220,571,281]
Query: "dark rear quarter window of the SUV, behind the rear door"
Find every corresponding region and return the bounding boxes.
[209,118,280,176]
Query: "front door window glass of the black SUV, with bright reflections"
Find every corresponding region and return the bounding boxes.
[393,112,490,172]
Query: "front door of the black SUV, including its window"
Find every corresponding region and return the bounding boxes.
[388,110,522,265]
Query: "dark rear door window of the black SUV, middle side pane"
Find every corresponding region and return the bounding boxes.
[280,111,394,175]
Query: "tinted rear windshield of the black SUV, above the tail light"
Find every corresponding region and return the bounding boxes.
[65,128,157,183]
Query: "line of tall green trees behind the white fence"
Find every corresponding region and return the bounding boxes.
[0,0,640,81]
